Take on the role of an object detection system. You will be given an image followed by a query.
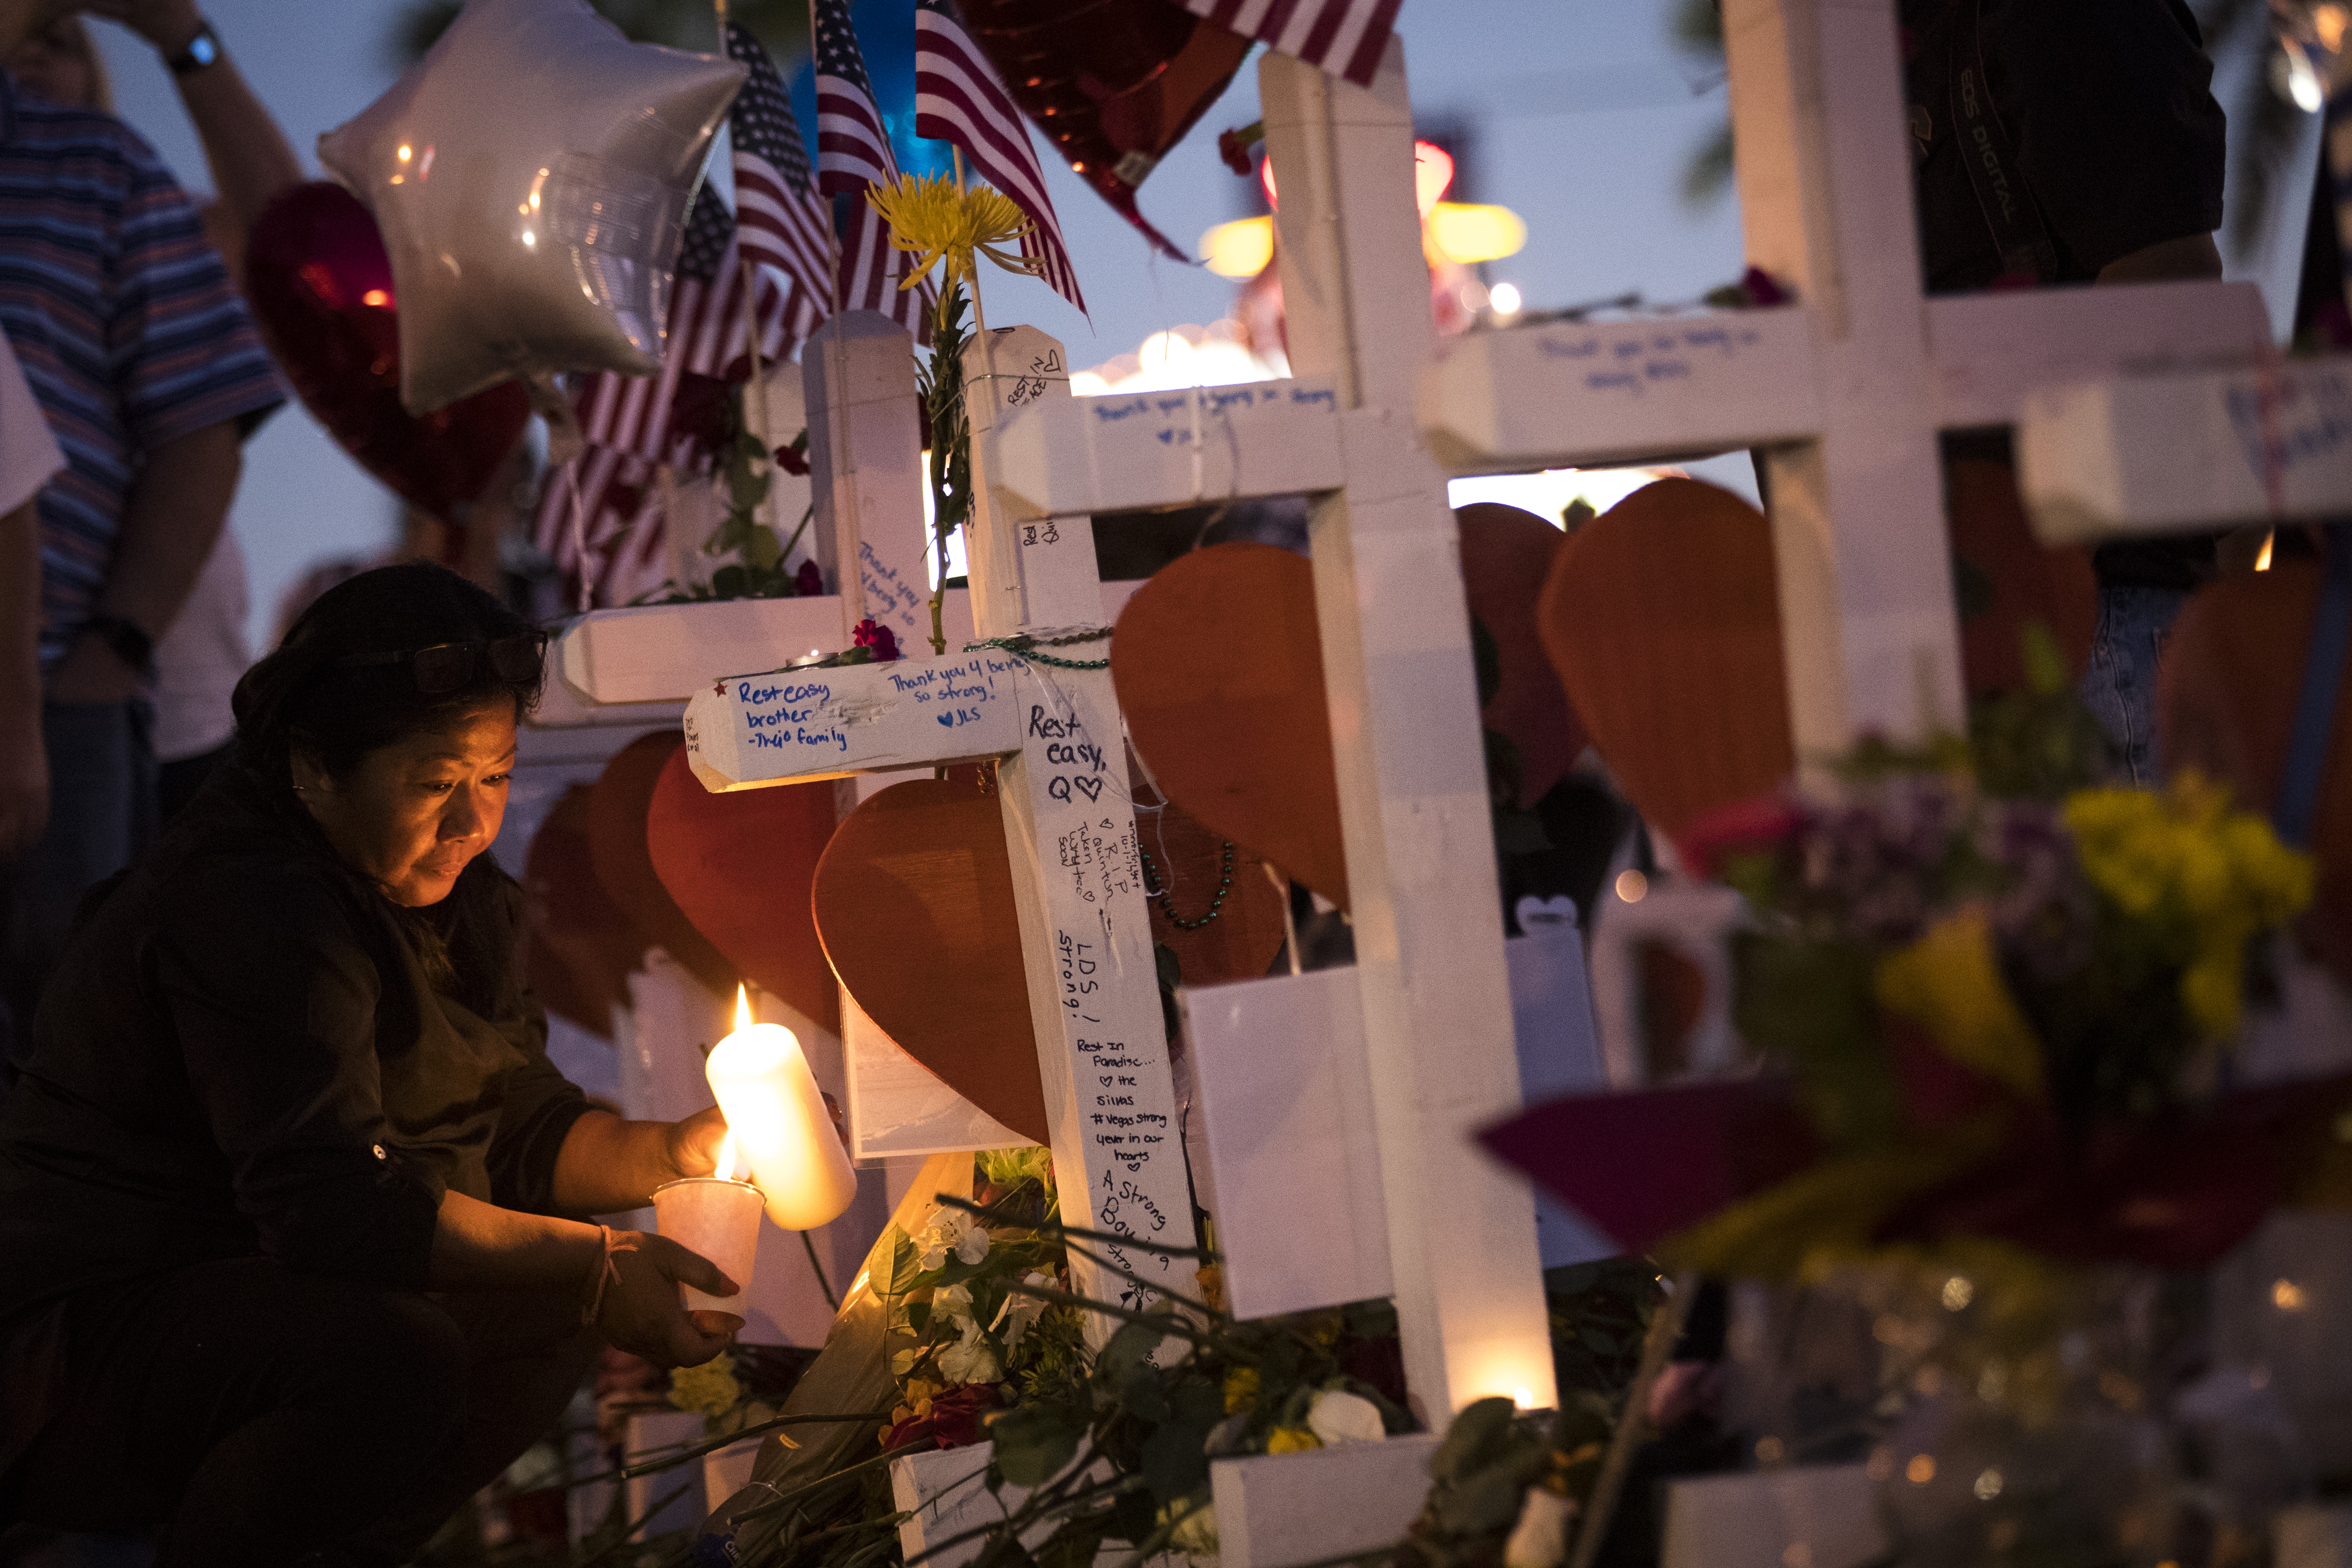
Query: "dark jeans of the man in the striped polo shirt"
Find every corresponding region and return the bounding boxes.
[0,701,155,1098]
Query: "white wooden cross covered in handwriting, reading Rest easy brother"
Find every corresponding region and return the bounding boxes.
[684,327,1193,1333]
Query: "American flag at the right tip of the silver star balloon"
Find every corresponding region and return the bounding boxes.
[727,21,833,353]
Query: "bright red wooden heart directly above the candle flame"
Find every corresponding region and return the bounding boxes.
[644,748,842,1034]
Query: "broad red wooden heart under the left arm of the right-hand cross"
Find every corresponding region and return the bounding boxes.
[1538,479,1797,835]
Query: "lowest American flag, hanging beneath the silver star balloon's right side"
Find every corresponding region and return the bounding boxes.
[531,186,793,604]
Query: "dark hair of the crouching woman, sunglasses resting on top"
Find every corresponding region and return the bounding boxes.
[231,562,538,802]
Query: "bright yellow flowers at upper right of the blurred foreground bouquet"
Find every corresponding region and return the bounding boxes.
[2065,776,2312,1039]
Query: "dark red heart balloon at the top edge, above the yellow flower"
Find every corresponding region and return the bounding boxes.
[964,0,1249,261]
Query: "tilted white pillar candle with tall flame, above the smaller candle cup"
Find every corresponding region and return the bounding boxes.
[703,987,859,1230]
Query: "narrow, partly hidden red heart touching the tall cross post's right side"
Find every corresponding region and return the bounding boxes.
[1453,503,1587,807]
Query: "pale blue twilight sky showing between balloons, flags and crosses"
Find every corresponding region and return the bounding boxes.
[92,0,2307,651]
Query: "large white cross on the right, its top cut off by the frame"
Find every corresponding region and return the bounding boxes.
[1421,0,2270,757]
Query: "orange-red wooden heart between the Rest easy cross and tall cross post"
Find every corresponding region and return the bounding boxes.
[1110,543,1347,907]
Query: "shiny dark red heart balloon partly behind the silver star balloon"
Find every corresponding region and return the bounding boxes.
[244,181,531,522]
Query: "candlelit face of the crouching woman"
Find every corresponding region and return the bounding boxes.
[294,703,515,910]
